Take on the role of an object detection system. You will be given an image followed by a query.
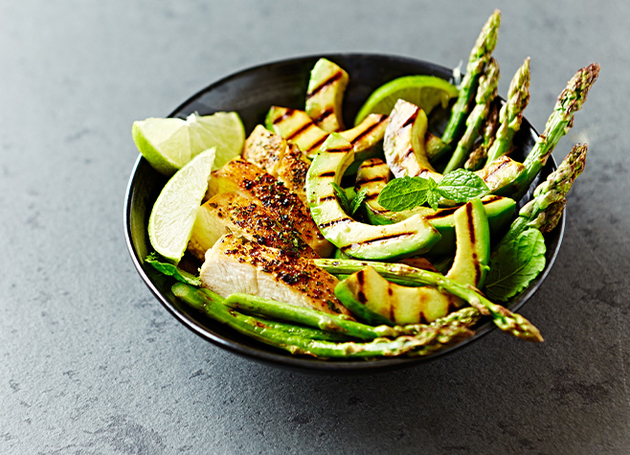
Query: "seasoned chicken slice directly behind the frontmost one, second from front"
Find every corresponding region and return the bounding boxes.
[188,193,318,261]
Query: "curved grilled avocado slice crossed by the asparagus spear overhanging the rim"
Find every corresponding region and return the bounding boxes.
[335,199,490,325]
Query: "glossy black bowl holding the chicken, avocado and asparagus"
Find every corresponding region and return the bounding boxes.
[124,54,565,373]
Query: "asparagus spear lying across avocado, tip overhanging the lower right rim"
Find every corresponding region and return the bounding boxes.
[313,259,543,341]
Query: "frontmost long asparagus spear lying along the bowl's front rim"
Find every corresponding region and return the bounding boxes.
[172,283,472,359]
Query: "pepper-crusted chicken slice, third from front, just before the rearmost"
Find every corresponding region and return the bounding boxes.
[206,158,333,257]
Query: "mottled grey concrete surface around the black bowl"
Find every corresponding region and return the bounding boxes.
[0,0,630,454]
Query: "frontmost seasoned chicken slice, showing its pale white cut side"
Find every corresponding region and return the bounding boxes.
[200,234,350,315]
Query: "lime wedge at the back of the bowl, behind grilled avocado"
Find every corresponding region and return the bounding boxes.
[354,75,459,125]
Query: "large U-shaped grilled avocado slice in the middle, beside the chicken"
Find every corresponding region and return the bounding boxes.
[306,133,440,260]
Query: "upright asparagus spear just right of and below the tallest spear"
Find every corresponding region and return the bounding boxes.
[444,58,499,174]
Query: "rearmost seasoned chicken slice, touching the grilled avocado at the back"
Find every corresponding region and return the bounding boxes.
[243,125,311,204]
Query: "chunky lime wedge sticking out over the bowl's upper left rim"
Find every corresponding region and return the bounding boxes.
[131,112,245,176]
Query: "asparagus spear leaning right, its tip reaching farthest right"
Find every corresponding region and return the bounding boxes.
[512,63,599,201]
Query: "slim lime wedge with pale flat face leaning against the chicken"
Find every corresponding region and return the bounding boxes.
[148,147,216,264]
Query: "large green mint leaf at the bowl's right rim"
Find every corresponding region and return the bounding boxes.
[485,228,546,301]
